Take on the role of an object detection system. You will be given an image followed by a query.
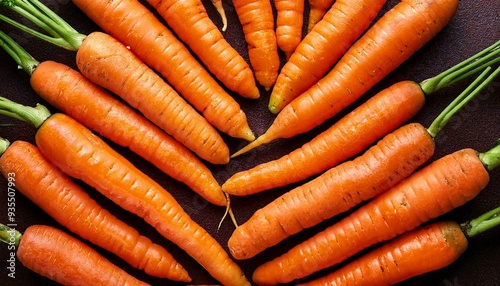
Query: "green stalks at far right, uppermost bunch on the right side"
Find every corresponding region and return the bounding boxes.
[420,41,500,95]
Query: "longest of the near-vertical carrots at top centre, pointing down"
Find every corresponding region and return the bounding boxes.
[233,0,280,90]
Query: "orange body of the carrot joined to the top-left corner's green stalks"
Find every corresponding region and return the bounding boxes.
[76,32,229,164]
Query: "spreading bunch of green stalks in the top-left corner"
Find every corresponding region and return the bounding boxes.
[0,0,86,51]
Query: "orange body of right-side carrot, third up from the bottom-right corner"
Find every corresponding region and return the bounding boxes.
[228,123,435,259]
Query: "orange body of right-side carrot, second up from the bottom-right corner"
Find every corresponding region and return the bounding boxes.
[253,149,489,285]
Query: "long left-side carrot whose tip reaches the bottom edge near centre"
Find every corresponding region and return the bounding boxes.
[35,113,249,285]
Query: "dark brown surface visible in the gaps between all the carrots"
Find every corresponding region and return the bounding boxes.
[0,0,500,286]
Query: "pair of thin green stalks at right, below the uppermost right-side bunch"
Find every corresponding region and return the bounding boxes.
[427,67,500,138]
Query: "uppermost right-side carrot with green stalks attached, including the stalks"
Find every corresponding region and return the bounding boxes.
[222,41,500,195]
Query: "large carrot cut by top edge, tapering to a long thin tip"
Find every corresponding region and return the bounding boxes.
[232,0,458,154]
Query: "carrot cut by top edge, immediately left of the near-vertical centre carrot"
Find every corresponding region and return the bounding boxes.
[148,0,260,99]
